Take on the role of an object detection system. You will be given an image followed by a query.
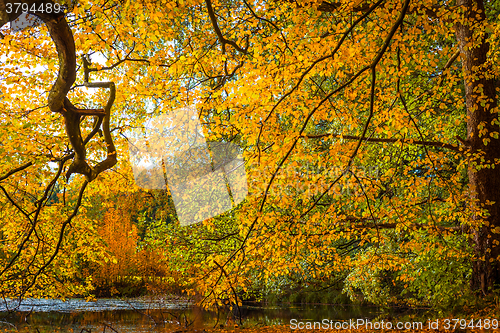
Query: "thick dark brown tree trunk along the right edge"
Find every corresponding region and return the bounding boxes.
[455,0,500,294]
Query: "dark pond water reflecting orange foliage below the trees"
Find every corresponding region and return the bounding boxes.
[0,298,396,333]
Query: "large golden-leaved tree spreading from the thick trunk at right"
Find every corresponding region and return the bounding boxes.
[0,0,500,304]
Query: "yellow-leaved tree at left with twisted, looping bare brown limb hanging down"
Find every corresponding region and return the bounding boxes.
[0,1,120,297]
